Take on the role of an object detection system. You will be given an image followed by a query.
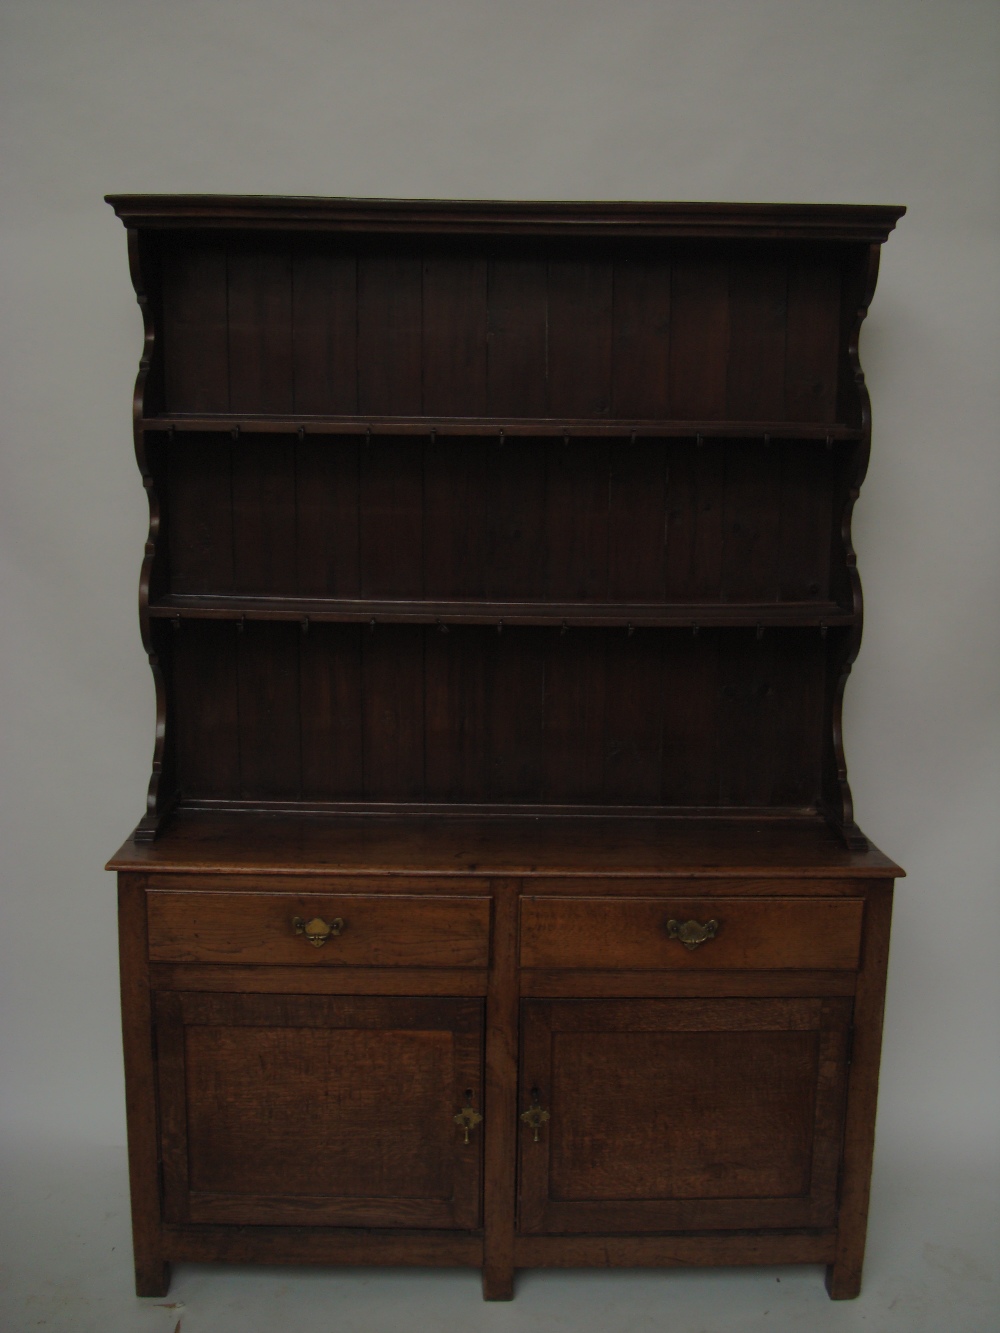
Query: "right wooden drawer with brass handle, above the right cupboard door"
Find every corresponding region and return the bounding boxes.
[520,897,864,970]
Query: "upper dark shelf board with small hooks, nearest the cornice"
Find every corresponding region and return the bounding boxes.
[139,412,861,443]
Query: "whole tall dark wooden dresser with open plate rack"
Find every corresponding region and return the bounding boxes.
[111,196,901,1300]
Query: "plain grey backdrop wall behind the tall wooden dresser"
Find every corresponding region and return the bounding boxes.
[0,0,1000,1329]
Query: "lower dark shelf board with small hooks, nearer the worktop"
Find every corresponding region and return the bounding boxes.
[149,595,855,629]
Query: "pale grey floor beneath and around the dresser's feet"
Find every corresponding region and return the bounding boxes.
[0,1146,1000,1333]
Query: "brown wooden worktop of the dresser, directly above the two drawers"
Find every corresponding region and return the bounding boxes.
[108,815,903,879]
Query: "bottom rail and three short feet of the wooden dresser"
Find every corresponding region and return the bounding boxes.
[136,1225,860,1301]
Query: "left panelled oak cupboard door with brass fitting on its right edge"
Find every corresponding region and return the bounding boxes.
[156,992,483,1229]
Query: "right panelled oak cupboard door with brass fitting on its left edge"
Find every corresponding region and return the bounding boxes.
[519,998,852,1234]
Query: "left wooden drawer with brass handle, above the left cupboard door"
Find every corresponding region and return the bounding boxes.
[147,889,491,968]
